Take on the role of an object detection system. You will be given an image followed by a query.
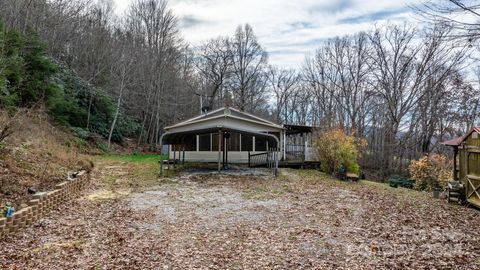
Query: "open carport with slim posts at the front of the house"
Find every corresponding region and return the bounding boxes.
[160,126,282,175]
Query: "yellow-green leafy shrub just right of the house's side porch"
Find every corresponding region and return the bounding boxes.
[314,129,366,174]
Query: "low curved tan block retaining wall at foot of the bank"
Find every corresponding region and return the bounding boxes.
[0,171,90,237]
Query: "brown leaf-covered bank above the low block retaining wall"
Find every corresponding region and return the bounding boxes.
[0,109,89,210]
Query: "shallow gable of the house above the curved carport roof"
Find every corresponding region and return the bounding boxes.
[165,107,283,130]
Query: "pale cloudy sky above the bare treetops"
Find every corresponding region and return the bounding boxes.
[114,0,419,67]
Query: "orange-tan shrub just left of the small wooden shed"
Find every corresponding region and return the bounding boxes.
[409,154,452,191]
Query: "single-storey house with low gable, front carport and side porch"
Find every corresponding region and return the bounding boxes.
[160,107,314,172]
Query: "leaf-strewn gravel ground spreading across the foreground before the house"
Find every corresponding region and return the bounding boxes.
[0,157,480,269]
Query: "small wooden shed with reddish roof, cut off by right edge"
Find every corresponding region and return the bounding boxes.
[442,127,480,207]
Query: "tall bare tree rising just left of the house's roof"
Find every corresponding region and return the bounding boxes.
[127,0,187,148]
